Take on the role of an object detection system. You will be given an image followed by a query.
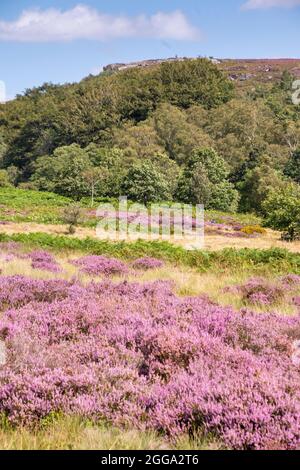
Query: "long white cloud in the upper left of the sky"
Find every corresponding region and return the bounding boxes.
[0,5,199,42]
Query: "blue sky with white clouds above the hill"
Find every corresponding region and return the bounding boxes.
[0,0,300,100]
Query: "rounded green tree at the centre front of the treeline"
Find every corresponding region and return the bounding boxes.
[122,161,171,204]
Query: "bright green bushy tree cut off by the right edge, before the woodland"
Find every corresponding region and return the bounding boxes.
[263,183,300,241]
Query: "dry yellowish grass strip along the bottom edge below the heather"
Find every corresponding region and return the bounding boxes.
[0,417,222,450]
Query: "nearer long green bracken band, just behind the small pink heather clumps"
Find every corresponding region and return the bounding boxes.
[0,233,300,274]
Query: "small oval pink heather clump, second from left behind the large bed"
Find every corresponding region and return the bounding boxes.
[72,255,128,276]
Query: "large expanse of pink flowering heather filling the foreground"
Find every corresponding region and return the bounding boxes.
[0,276,300,449]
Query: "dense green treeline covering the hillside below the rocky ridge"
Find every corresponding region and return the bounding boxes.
[0,59,300,219]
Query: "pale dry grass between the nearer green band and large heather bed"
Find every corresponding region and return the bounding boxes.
[0,250,300,315]
